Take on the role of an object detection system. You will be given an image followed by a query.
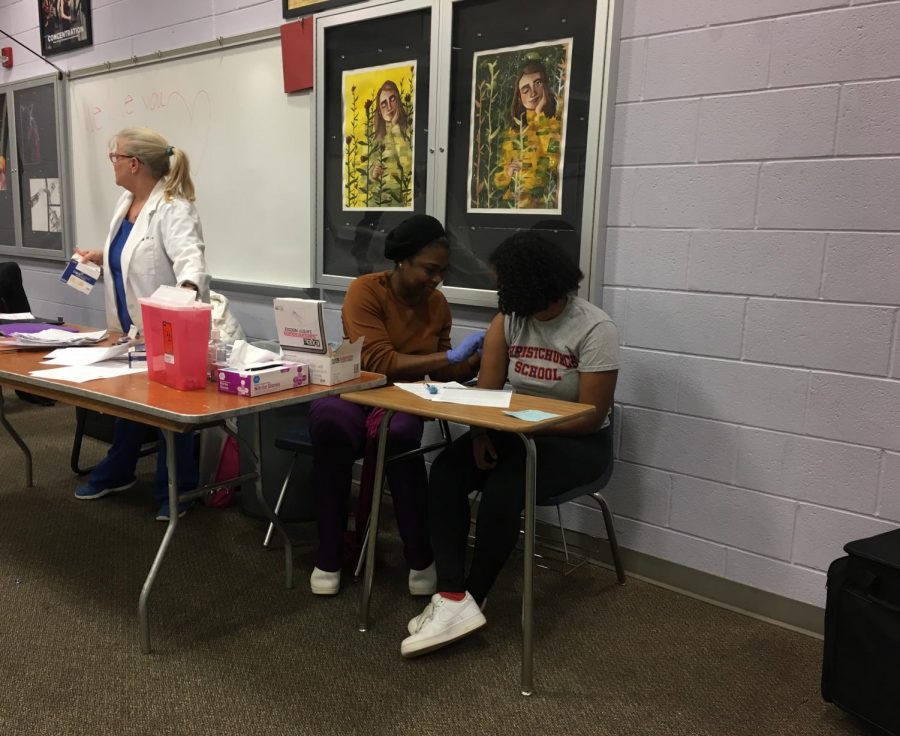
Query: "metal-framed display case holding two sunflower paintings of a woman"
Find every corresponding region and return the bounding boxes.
[315,0,618,306]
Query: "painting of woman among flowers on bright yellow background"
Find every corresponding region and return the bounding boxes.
[341,59,416,212]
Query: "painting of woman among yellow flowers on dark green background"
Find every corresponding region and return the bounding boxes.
[467,38,573,215]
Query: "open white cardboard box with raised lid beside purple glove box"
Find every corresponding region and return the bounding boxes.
[275,297,363,386]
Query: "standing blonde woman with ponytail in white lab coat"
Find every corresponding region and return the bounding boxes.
[75,128,210,521]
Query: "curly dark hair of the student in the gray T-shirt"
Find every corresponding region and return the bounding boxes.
[488,230,584,317]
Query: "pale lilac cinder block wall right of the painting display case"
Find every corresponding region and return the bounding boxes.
[600,0,900,605]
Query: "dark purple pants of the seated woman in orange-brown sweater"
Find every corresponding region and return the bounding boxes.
[309,396,433,572]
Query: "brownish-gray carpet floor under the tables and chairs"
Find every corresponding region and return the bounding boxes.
[0,391,865,736]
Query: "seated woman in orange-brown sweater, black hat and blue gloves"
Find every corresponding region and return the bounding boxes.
[309,215,484,595]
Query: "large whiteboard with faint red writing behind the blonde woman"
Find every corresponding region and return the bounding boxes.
[69,38,313,287]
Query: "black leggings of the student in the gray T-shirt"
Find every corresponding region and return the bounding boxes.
[428,427,612,604]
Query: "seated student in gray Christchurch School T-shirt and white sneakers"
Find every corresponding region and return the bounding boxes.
[400,231,619,657]
